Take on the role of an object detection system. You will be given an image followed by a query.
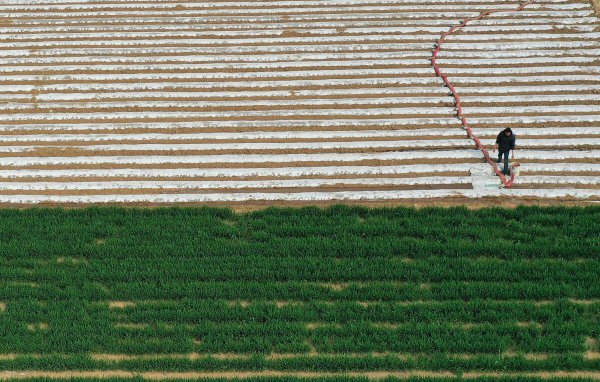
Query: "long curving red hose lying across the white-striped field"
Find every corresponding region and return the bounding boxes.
[431,0,536,188]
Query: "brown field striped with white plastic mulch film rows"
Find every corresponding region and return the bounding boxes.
[0,0,600,205]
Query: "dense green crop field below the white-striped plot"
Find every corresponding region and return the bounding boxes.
[0,206,600,382]
